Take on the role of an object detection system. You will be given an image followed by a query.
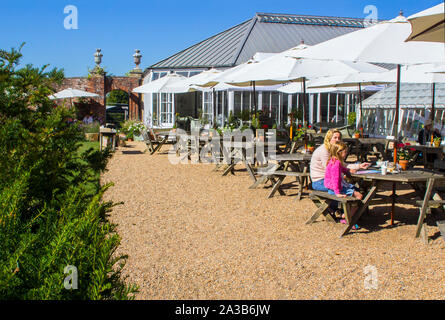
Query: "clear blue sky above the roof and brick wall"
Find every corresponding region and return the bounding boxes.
[0,0,441,77]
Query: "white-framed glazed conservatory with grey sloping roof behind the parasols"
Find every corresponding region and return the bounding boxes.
[143,13,386,128]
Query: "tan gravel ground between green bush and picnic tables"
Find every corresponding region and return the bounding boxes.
[102,142,445,300]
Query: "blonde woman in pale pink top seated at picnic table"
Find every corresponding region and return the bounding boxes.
[310,129,371,192]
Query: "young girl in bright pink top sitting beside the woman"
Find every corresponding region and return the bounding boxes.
[324,141,363,229]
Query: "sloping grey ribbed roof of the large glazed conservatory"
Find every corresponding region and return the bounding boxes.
[146,13,372,71]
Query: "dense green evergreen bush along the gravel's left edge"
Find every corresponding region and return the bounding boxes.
[0,48,136,299]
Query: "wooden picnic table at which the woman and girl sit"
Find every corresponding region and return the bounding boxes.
[345,169,445,241]
